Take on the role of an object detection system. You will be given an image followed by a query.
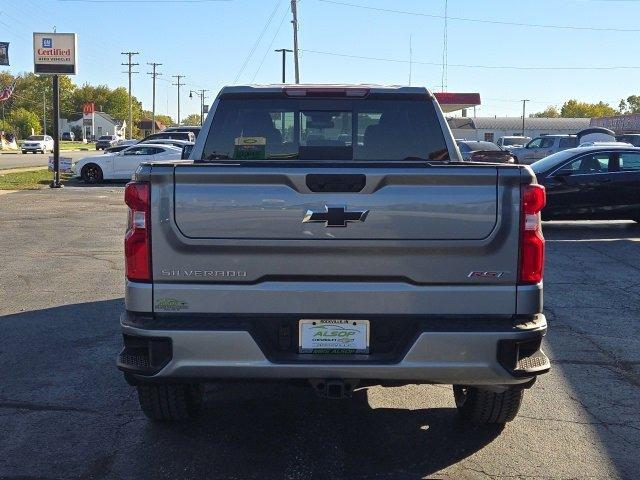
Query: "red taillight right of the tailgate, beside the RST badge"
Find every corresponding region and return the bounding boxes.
[518,185,547,283]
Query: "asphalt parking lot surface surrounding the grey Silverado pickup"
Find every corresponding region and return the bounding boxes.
[0,185,640,480]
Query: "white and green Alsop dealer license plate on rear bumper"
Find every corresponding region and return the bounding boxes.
[298,320,369,354]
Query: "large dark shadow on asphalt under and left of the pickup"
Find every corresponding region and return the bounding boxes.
[0,299,500,479]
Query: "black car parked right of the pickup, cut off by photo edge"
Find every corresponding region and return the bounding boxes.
[531,145,640,222]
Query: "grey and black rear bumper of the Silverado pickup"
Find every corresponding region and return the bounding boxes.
[118,313,549,385]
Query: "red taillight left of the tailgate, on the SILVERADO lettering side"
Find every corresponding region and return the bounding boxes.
[124,182,151,282]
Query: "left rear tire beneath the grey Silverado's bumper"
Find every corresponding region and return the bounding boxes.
[136,383,204,422]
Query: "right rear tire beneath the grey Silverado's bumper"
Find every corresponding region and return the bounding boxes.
[453,385,524,425]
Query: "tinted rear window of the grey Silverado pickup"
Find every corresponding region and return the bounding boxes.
[201,96,449,161]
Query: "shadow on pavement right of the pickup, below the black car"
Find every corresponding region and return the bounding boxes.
[543,221,640,478]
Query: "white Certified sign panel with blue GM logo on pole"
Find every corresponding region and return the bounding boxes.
[33,33,77,75]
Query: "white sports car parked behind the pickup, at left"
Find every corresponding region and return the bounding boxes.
[72,143,182,183]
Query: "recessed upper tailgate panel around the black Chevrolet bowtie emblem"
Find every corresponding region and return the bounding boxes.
[174,166,497,241]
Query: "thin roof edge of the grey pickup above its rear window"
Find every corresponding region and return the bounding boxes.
[220,83,432,97]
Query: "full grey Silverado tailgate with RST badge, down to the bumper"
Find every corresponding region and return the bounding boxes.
[151,164,520,314]
